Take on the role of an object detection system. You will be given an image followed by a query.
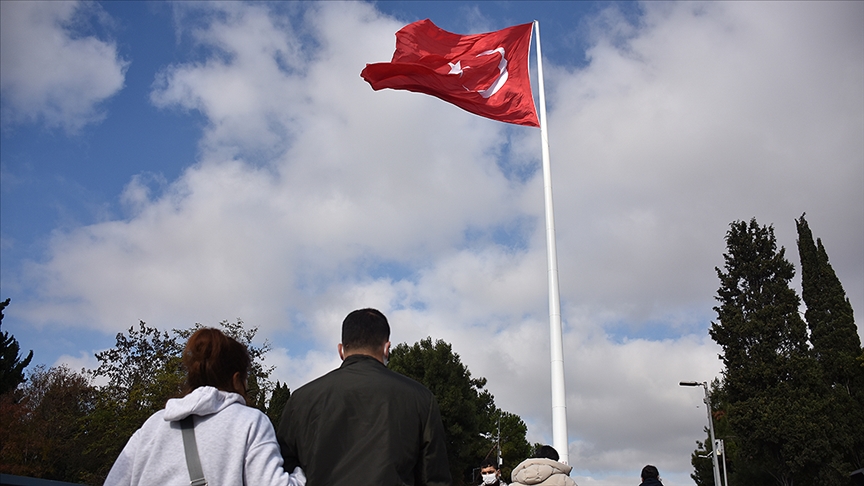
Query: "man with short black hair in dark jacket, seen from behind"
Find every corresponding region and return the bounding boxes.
[276,309,451,486]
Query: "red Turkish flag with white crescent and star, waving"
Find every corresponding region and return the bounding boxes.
[360,19,540,127]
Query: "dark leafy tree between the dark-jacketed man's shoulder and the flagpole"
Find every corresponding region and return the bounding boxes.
[389,337,531,485]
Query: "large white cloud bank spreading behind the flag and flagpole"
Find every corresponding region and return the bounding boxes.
[8,2,864,485]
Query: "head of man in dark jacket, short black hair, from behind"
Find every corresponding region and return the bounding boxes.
[339,309,390,363]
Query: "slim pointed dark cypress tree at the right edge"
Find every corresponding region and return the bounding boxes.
[795,214,864,473]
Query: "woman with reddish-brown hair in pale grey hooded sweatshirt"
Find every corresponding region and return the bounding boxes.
[105,328,306,486]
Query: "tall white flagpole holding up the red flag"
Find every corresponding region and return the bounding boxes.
[534,20,569,464]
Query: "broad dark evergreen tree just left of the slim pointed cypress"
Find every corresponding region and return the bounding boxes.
[709,219,838,486]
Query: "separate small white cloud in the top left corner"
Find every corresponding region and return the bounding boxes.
[0,1,129,132]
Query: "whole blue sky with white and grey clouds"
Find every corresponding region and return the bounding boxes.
[0,1,864,486]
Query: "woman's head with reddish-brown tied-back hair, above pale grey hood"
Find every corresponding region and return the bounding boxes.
[183,327,252,402]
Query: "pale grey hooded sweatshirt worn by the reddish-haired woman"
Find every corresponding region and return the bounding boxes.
[105,386,306,486]
